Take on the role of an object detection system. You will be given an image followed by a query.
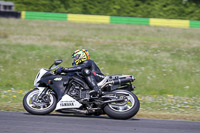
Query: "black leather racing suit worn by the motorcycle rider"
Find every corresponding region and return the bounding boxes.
[63,59,103,92]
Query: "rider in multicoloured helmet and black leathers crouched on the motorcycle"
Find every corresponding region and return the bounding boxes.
[57,49,103,96]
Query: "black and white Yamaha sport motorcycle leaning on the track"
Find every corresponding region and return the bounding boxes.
[23,60,140,119]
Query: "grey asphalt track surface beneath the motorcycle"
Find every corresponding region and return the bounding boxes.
[0,111,200,133]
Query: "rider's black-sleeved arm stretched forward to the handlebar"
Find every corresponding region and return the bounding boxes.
[62,60,91,72]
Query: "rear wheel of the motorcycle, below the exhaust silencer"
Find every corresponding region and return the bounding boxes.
[104,90,140,120]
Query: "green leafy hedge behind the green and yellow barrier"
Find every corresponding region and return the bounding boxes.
[5,0,200,20]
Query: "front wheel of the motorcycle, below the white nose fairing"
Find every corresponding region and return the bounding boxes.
[23,89,57,115]
